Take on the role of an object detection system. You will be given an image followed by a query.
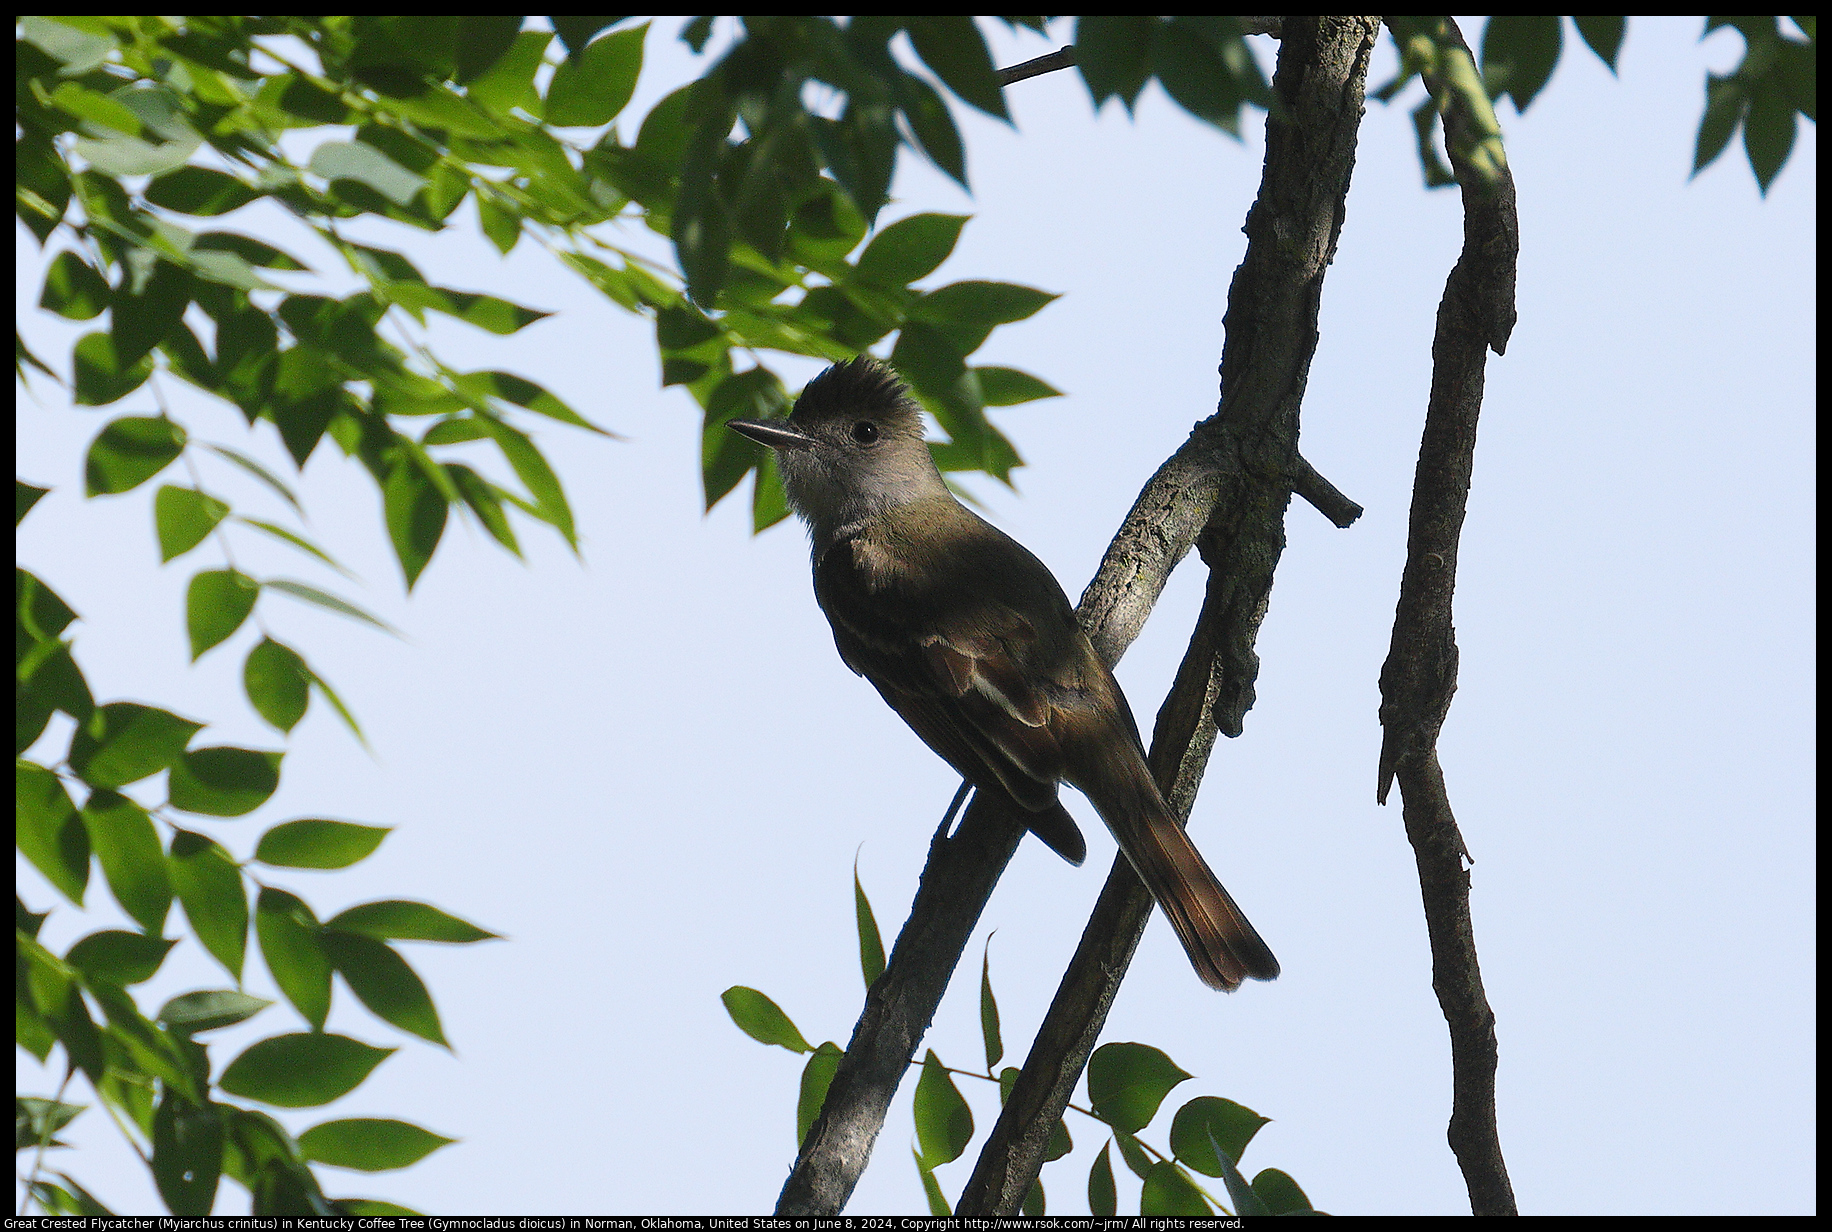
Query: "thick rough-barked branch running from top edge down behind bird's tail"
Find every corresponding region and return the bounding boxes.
[956,17,1379,1216]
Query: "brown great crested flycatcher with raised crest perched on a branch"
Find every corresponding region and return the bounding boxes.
[729,356,1279,992]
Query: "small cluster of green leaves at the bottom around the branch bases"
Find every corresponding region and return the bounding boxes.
[722,871,1319,1217]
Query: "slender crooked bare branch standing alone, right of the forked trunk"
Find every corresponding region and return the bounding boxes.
[1378,18,1521,1216]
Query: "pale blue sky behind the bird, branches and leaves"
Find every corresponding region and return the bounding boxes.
[16,18,1817,1214]
